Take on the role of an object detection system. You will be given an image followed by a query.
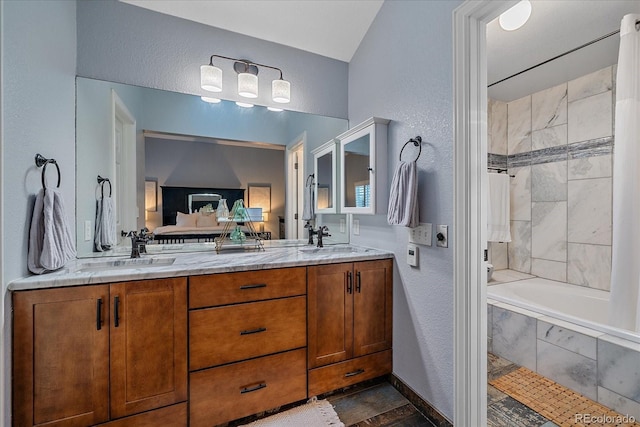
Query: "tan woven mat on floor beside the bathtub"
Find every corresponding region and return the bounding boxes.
[489,367,640,427]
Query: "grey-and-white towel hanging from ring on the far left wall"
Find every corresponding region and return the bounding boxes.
[27,188,76,274]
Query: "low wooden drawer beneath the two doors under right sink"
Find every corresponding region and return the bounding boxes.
[309,350,391,396]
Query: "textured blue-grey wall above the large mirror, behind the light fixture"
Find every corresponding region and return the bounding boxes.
[78,0,348,119]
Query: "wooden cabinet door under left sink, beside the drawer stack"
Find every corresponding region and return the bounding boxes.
[110,278,187,419]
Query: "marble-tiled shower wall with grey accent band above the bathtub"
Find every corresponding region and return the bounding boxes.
[488,65,616,290]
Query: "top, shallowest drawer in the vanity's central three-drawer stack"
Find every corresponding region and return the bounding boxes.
[189,267,307,308]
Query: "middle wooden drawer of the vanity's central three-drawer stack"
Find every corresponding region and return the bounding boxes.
[189,296,307,371]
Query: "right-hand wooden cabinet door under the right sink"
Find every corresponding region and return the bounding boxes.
[353,260,393,357]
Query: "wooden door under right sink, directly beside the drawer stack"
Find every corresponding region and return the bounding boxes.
[307,264,353,369]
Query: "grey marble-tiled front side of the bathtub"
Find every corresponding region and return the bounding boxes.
[487,300,640,419]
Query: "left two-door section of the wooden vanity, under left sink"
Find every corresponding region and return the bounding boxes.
[13,278,187,427]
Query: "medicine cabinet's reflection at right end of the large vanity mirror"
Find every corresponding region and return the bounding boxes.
[312,140,338,214]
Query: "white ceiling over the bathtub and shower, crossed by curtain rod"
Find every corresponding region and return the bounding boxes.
[487,0,640,101]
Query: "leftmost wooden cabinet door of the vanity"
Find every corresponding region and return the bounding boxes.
[13,285,109,426]
